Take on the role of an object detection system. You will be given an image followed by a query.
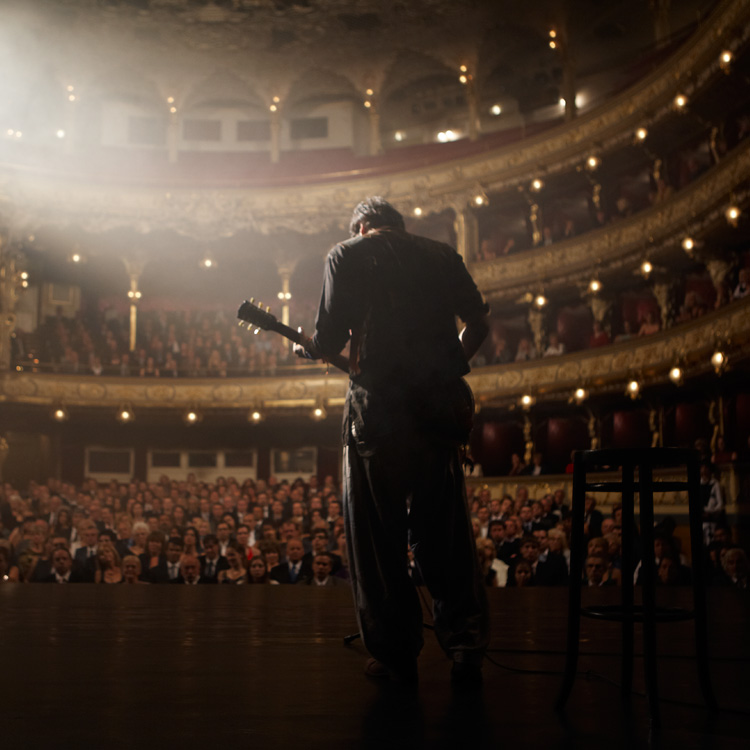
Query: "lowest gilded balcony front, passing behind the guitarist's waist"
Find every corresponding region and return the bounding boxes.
[0,298,750,411]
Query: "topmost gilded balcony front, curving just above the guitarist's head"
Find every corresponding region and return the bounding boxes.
[0,0,750,238]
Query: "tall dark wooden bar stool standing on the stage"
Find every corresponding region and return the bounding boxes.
[556,448,716,728]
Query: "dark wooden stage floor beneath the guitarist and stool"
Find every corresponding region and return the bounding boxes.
[0,584,750,750]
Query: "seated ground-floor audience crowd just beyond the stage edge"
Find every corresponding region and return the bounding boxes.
[0,456,748,588]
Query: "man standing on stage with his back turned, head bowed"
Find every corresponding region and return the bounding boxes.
[295,197,488,684]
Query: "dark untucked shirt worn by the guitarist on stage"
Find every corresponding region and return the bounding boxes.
[313,228,488,442]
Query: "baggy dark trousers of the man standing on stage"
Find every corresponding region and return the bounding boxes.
[344,433,489,667]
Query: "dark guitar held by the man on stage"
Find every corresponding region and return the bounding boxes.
[237,298,474,445]
